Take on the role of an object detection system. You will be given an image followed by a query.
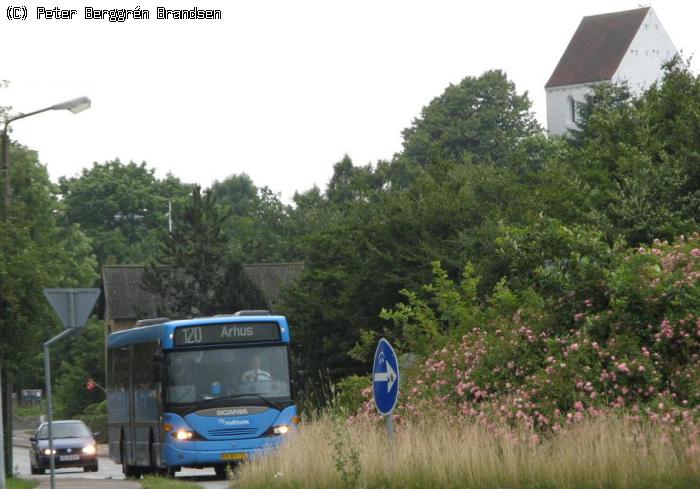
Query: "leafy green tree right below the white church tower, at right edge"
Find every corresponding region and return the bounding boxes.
[548,59,700,245]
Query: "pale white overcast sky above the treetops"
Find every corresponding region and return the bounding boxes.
[0,0,700,200]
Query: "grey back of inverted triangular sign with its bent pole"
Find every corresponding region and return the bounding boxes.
[44,289,100,489]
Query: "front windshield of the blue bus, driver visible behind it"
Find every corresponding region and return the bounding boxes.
[167,345,290,404]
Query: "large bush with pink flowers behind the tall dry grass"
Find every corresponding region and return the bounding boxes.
[352,234,700,436]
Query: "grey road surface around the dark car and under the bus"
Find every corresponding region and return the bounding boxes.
[12,433,228,489]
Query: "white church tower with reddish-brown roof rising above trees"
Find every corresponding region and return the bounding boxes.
[545,7,677,135]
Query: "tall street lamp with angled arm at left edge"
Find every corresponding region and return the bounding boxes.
[0,97,90,489]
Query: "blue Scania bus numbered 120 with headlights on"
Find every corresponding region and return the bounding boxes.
[107,311,299,477]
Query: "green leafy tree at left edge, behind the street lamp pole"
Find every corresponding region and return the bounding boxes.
[0,144,97,374]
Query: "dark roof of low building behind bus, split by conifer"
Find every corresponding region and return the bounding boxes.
[102,262,304,320]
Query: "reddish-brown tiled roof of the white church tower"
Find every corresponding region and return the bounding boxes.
[545,7,650,88]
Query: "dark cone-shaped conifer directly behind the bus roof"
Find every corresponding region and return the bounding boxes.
[144,187,266,317]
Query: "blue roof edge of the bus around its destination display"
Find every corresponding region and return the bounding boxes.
[107,315,289,348]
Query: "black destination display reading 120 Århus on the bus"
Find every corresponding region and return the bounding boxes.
[173,322,280,346]
